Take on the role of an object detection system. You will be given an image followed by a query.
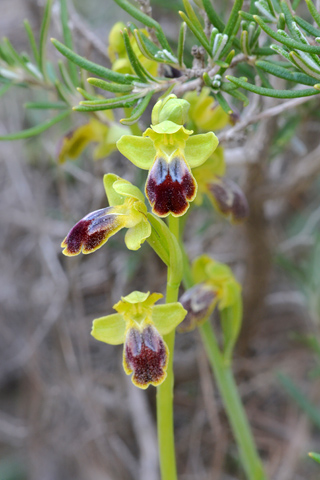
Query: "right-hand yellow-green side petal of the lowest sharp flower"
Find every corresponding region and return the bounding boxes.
[152,302,187,335]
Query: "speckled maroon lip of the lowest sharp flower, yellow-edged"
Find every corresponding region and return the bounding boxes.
[123,324,168,389]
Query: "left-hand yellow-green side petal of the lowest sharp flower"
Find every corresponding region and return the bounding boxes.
[91,313,126,345]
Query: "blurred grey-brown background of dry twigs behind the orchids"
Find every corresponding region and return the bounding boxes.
[0,0,320,480]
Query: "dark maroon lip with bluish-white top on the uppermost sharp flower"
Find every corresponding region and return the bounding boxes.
[146,157,196,217]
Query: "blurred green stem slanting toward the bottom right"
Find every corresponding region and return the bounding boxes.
[199,320,267,480]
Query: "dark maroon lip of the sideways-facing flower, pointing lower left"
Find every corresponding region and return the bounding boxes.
[61,207,125,256]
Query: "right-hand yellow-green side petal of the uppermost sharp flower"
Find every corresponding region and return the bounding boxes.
[184,132,219,168]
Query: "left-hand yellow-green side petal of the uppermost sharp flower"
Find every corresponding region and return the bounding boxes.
[117,135,156,170]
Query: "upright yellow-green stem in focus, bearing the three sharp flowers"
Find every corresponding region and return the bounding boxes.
[157,215,179,480]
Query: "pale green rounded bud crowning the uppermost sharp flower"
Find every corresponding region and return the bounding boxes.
[152,95,190,125]
